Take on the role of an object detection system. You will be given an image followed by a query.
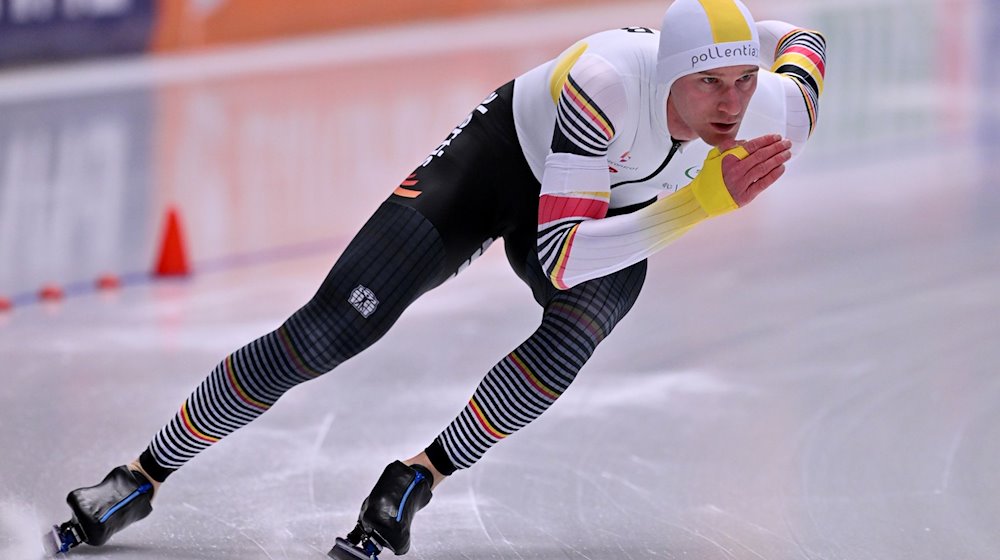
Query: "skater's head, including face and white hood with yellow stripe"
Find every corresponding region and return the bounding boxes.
[656,0,760,146]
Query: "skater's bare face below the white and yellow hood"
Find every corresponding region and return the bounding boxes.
[667,65,760,146]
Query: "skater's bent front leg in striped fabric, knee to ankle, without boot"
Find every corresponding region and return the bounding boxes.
[424,261,646,476]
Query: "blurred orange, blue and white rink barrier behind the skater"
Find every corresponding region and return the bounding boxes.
[0,0,1000,305]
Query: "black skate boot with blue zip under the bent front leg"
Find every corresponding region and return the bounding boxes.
[328,461,434,560]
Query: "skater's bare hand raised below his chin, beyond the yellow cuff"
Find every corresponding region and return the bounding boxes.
[717,134,792,208]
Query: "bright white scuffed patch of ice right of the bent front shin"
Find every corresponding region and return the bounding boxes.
[552,371,744,416]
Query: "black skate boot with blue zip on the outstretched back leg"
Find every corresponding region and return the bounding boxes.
[45,466,153,555]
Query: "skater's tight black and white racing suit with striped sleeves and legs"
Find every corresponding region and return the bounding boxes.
[141,22,825,480]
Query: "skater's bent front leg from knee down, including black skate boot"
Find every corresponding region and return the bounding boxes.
[340,261,646,558]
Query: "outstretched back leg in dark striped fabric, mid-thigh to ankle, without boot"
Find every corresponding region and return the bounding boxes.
[139,203,444,482]
